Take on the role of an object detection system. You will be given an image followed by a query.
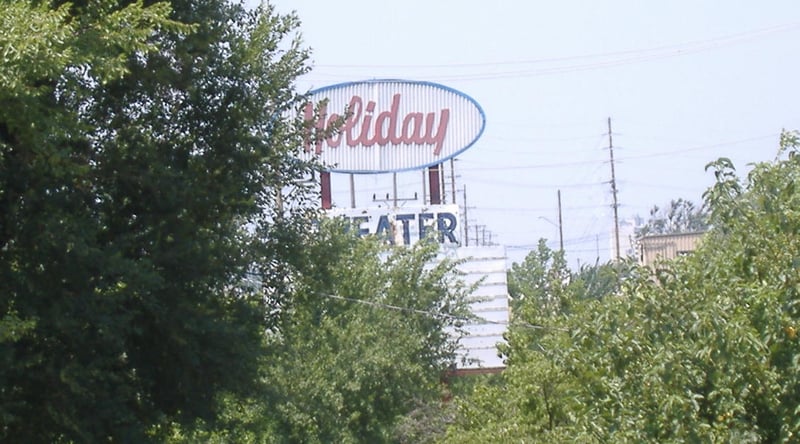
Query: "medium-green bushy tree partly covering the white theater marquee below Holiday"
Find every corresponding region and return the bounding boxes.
[175,222,468,442]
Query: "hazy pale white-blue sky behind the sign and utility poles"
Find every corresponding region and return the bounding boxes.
[272,0,800,265]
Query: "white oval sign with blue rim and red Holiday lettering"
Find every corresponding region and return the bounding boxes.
[305,79,486,174]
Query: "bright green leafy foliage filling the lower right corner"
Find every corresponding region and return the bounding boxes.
[448,133,800,442]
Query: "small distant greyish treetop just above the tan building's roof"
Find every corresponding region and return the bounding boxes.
[636,198,708,236]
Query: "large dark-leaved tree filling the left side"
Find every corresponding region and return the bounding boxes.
[0,0,313,442]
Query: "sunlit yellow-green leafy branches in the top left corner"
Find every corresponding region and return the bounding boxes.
[0,0,184,92]
